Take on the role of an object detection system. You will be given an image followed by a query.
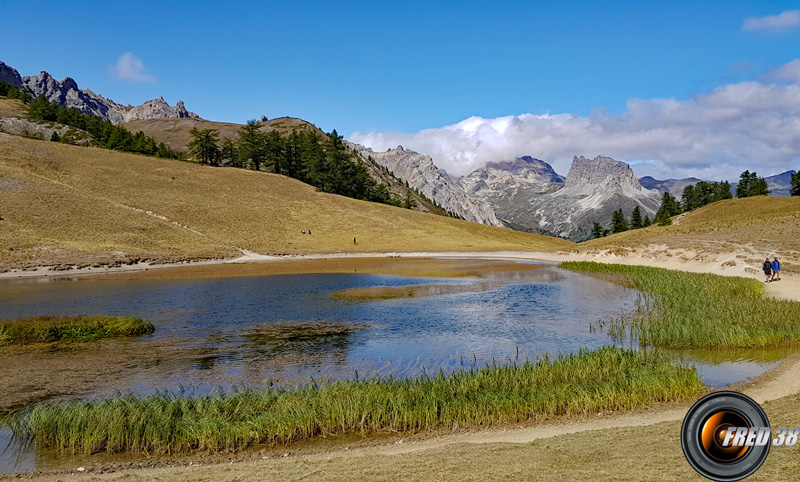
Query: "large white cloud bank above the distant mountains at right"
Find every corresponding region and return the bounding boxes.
[348,60,800,180]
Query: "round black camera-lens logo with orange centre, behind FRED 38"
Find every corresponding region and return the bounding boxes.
[681,391,772,482]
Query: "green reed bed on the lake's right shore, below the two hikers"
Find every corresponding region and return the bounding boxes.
[561,262,800,348]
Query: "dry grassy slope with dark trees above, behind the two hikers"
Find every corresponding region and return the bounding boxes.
[579,196,800,266]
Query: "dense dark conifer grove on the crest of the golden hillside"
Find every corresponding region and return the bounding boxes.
[186,120,400,208]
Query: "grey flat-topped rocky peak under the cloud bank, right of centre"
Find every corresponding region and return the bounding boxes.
[523,156,661,241]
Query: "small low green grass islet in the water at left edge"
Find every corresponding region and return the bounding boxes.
[0,315,156,346]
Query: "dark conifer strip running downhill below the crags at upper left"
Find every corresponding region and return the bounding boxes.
[28,95,183,159]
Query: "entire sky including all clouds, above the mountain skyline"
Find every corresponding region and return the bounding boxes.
[0,1,800,182]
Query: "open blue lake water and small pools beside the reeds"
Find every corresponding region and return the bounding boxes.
[0,266,785,473]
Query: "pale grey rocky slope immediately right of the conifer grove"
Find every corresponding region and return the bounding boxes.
[348,143,503,226]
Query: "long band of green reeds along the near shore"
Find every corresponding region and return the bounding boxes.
[10,346,704,454]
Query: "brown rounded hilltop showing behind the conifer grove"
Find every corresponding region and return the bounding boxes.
[122,117,324,151]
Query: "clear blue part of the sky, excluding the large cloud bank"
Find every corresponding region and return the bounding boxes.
[0,1,800,177]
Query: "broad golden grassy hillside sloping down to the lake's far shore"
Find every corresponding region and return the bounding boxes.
[0,134,574,270]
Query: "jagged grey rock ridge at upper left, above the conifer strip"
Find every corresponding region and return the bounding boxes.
[0,62,199,124]
